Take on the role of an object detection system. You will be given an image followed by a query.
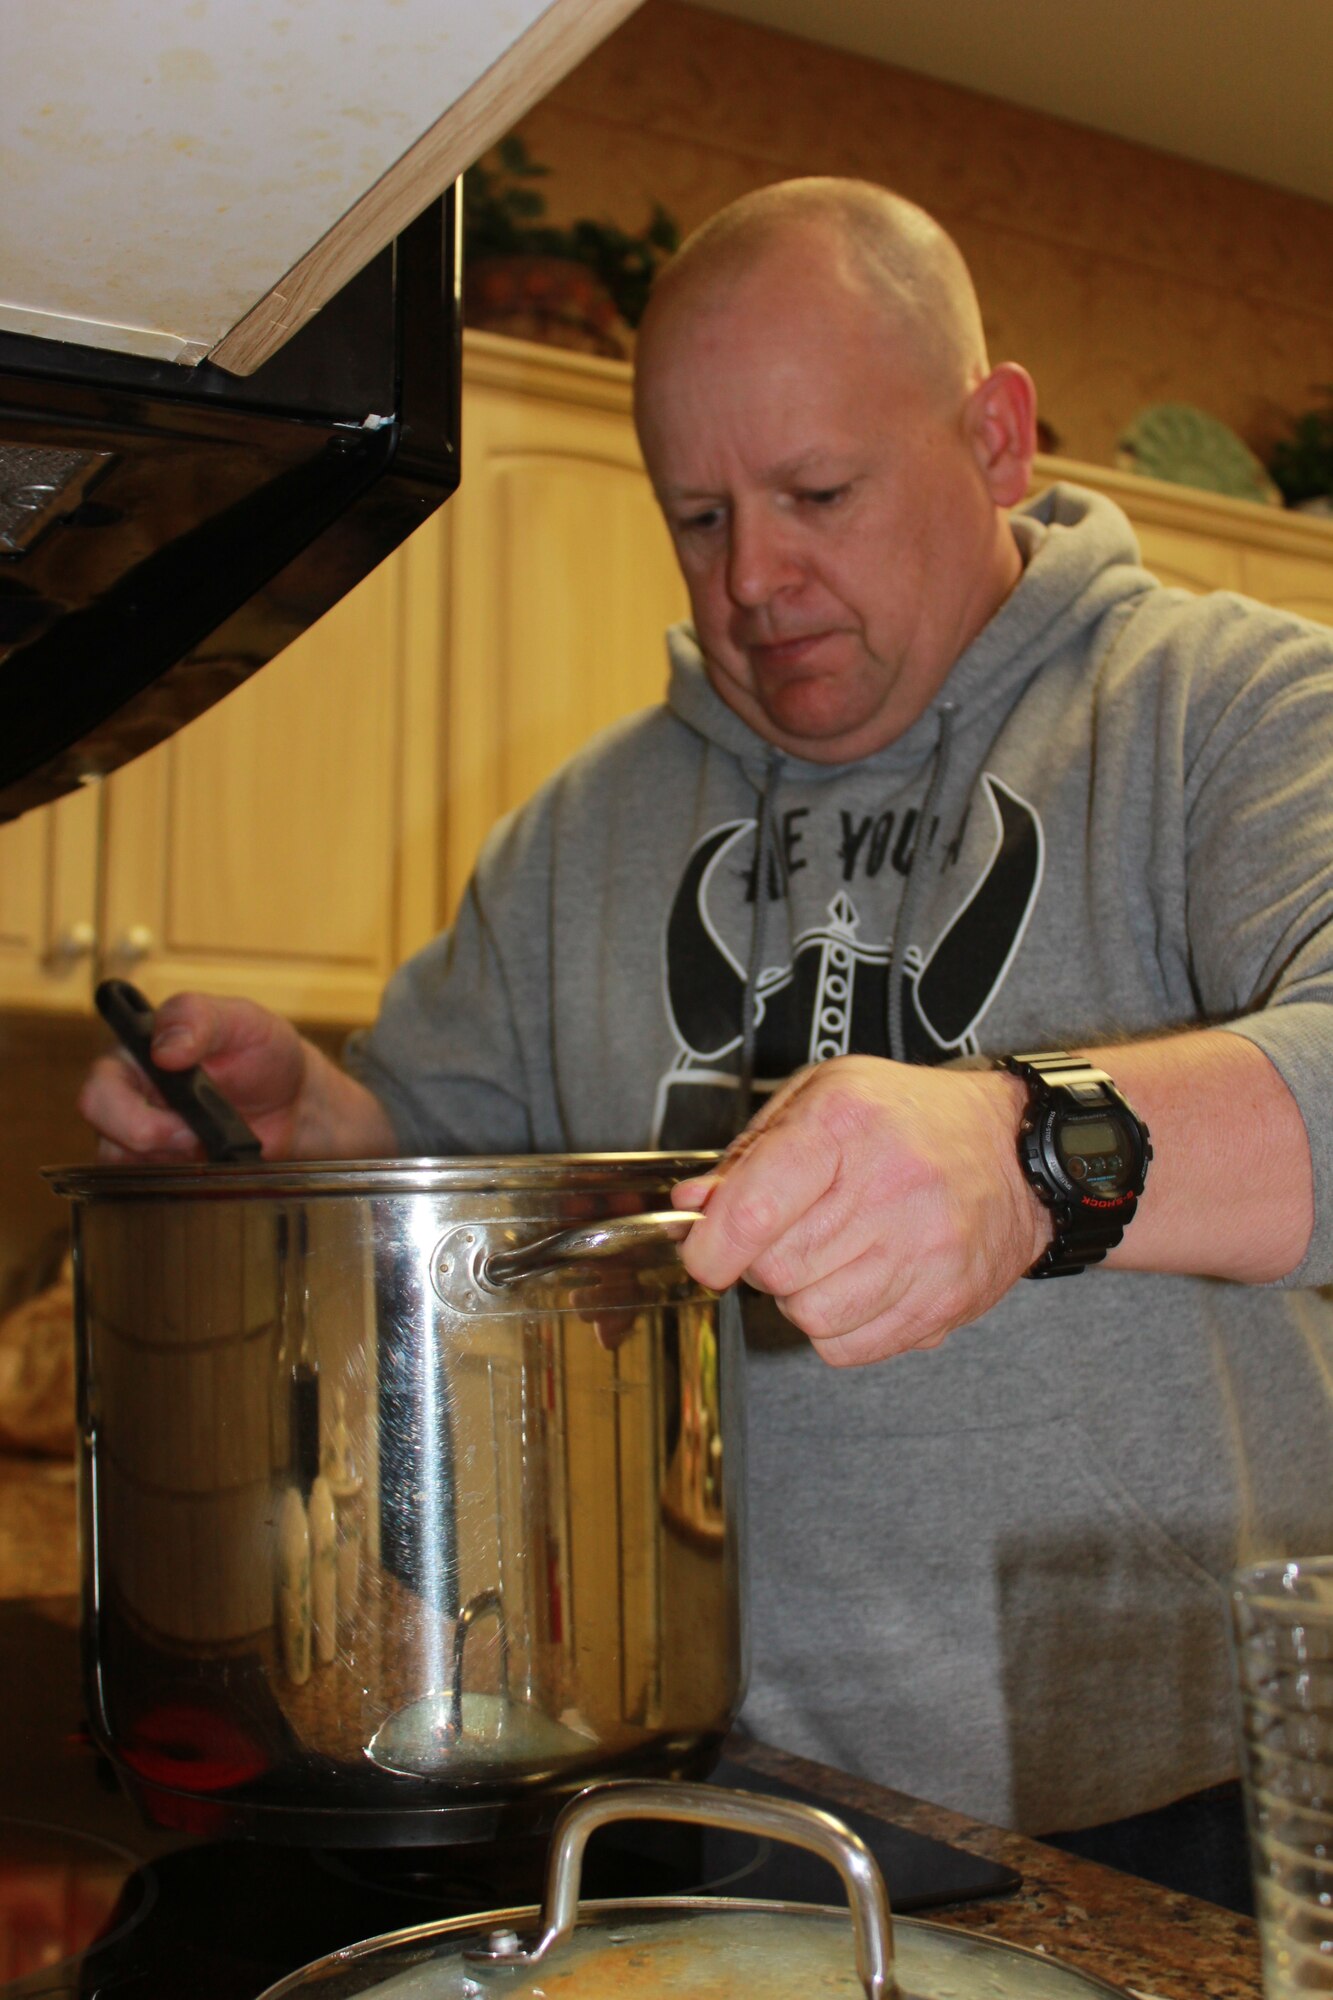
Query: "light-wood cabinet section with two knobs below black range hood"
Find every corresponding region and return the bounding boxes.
[0,524,442,1022]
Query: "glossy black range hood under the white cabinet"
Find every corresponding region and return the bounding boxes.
[0,188,462,820]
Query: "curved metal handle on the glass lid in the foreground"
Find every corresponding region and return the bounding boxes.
[464,1780,897,2000]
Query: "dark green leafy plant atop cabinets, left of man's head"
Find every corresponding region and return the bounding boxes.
[462,132,681,326]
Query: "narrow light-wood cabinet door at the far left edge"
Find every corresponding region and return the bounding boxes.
[0,788,98,1014]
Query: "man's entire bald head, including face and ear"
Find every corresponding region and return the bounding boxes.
[634,180,1035,762]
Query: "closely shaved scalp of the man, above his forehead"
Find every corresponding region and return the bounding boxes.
[638,178,989,414]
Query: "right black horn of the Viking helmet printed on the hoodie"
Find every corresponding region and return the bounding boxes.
[905,770,1045,1062]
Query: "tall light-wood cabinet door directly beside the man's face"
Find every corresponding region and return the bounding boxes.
[446,368,689,910]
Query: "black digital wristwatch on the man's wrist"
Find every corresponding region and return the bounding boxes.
[995,1050,1153,1278]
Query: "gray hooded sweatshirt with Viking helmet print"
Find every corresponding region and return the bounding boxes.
[348,486,1333,1832]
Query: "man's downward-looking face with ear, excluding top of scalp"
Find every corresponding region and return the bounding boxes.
[638,244,1013,764]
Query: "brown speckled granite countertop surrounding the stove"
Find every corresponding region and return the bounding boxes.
[0,1454,1263,2000]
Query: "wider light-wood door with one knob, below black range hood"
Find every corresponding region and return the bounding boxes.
[104,552,430,1022]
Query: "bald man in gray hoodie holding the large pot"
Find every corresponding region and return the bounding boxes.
[84,180,1333,1832]
